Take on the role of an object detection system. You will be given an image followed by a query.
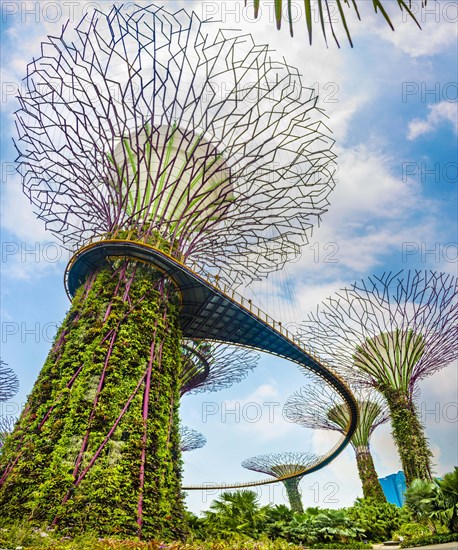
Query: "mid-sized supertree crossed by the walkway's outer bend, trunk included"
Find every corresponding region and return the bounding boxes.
[283,381,389,502]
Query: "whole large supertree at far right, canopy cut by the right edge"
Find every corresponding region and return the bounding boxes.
[300,271,458,484]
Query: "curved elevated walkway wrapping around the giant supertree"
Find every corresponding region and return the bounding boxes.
[65,240,358,490]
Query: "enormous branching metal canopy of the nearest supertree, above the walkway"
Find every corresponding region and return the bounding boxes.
[16,5,334,286]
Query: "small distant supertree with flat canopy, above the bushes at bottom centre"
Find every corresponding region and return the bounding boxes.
[242,453,320,512]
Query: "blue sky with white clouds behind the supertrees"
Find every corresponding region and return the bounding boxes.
[0,0,458,511]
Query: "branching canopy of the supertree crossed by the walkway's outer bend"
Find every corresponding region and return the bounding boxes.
[284,380,389,448]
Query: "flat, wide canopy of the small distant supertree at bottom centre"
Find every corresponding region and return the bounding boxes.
[242,452,321,480]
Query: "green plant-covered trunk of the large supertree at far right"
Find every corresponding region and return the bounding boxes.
[380,387,432,485]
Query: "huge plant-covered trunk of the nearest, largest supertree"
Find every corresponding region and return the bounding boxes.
[0,260,185,540]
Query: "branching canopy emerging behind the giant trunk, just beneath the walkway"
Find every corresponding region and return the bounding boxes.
[181,340,259,395]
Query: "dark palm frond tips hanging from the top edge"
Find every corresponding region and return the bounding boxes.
[245,0,428,47]
